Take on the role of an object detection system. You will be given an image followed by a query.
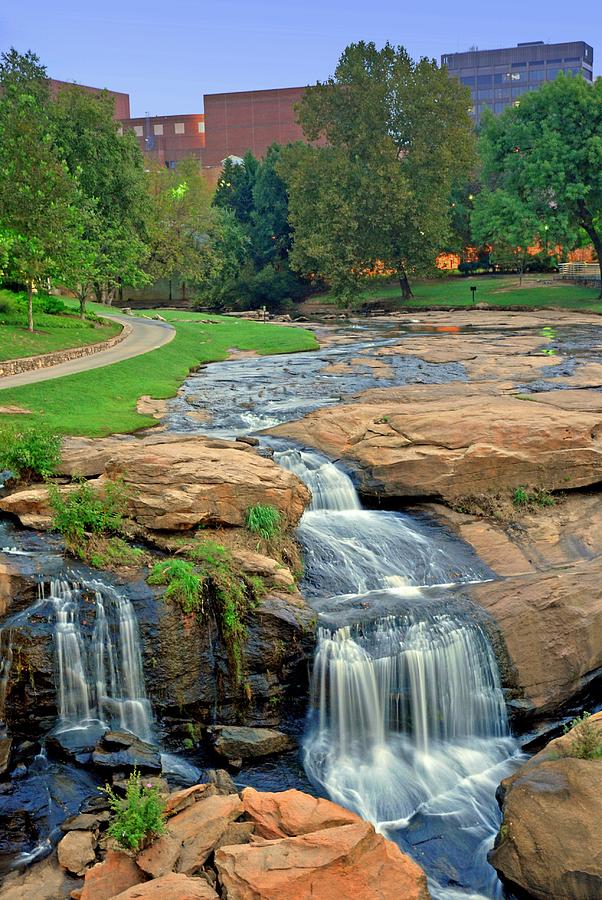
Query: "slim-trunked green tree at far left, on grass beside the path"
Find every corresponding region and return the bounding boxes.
[0,50,82,331]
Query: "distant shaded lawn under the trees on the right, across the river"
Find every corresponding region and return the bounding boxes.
[310,275,602,312]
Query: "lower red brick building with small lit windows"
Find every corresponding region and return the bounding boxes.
[120,113,205,169]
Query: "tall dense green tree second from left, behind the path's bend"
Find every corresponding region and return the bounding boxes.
[51,85,149,317]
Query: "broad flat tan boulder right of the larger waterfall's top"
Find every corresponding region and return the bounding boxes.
[271,385,602,501]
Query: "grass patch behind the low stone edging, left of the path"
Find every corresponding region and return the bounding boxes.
[0,290,121,360]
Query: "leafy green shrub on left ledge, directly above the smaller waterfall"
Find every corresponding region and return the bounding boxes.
[48,481,128,556]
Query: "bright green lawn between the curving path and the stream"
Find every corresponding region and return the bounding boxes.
[0,308,318,437]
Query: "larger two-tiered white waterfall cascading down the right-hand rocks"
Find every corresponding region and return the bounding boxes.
[276,450,516,898]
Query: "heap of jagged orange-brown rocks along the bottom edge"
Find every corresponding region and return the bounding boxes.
[2,776,430,900]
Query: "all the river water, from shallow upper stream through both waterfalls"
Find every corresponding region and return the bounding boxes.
[5,316,598,900]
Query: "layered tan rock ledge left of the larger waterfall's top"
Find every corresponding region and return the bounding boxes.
[0,434,310,532]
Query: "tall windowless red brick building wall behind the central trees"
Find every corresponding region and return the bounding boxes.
[203,87,306,168]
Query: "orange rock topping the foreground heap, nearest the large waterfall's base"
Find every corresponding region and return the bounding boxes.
[242,788,362,839]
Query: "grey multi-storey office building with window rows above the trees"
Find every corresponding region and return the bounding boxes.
[441,41,594,123]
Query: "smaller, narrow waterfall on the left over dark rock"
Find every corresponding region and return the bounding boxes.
[47,581,152,739]
